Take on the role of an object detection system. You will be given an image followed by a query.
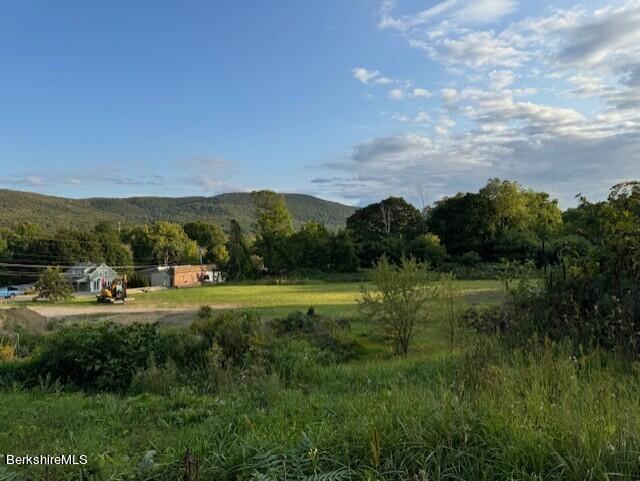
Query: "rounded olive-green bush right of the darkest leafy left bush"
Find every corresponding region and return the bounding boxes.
[191,306,264,366]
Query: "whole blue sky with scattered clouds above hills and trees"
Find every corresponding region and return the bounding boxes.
[0,0,640,207]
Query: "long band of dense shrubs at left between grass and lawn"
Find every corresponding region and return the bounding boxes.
[0,306,357,394]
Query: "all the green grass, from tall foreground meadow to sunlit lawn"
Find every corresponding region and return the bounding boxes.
[0,281,640,481]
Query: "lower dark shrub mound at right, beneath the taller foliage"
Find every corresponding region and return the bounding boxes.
[464,256,640,357]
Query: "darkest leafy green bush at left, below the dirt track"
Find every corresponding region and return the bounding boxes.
[26,323,165,391]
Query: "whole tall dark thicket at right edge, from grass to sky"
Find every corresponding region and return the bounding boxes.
[467,183,640,357]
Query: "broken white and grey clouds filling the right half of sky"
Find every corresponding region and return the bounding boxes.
[336,0,640,205]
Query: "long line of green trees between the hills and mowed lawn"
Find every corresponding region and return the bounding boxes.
[0,179,632,284]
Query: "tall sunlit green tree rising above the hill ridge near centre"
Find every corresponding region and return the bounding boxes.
[251,190,293,274]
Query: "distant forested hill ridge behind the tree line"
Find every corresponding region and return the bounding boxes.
[0,189,355,230]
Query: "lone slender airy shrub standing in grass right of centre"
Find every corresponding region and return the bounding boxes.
[359,256,437,355]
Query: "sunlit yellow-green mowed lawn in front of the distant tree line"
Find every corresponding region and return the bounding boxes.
[131,281,500,315]
